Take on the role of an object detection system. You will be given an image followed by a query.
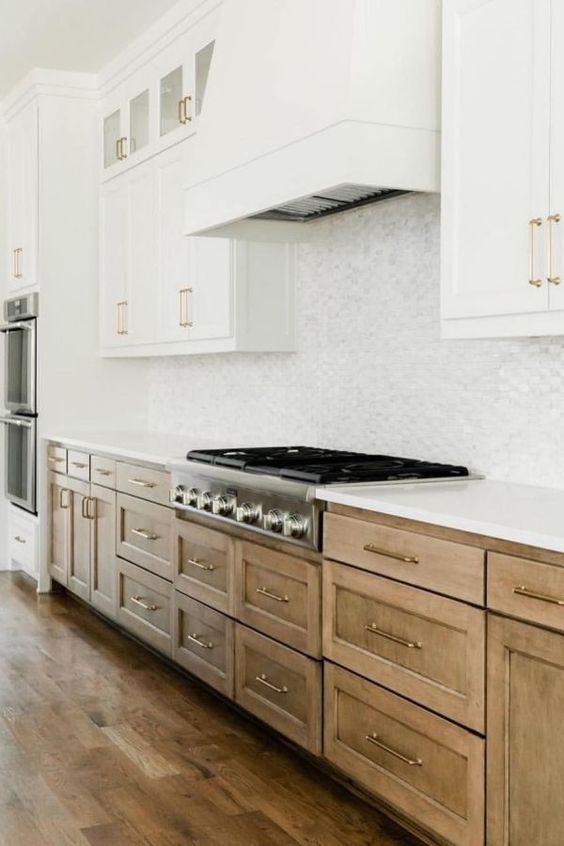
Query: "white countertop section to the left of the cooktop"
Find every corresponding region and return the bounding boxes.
[43,429,225,465]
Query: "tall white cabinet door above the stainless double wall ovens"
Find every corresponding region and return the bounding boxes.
[6,103,39,291]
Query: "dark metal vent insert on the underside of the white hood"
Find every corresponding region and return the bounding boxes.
[250,185,407,223]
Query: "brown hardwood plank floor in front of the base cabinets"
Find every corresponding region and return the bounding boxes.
[0,573,419,846]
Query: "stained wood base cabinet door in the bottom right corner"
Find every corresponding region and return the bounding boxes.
[487,615,564,846]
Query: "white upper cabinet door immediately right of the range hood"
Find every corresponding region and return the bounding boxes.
[442,0,550,318]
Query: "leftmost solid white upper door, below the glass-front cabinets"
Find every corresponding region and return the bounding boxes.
[100,177,130,347]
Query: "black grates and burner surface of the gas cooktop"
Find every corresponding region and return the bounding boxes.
[187,446,468,485]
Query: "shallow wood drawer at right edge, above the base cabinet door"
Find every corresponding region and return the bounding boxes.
[487,552,564,630]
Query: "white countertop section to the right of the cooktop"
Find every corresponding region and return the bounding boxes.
[317,479,564,552]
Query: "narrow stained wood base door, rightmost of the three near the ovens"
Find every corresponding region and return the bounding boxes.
[90,485,116,619]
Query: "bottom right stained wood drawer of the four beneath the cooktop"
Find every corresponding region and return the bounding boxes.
[235,623,321,755]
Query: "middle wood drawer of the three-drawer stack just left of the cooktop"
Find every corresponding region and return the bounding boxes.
[117,494,173,581]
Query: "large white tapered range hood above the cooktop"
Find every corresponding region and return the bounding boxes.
[186,0,441,237]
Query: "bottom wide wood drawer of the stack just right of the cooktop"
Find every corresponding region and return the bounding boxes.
[324,663,485,846]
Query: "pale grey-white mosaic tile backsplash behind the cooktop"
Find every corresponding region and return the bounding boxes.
[149,190,564,486]
